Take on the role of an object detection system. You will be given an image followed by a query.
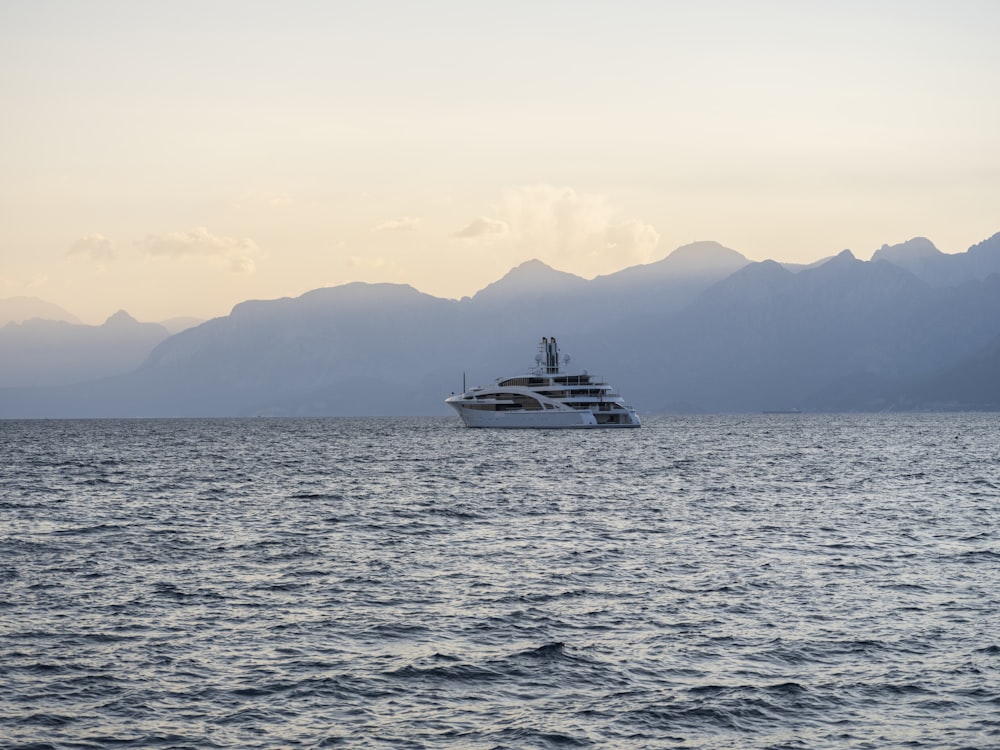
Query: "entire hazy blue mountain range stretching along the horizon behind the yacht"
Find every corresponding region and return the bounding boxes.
[0,234,1000,418]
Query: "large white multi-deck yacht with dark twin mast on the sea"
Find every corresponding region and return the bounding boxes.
[445,337,639,428]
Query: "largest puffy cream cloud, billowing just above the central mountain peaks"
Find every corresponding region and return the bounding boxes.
[462,185,660,274]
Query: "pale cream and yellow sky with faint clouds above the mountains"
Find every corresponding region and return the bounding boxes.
[0,0,1000,324]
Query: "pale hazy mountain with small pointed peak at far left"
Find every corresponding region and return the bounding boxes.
[0,311,169,387]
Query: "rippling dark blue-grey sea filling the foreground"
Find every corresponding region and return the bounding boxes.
[0,414,1000,750]
